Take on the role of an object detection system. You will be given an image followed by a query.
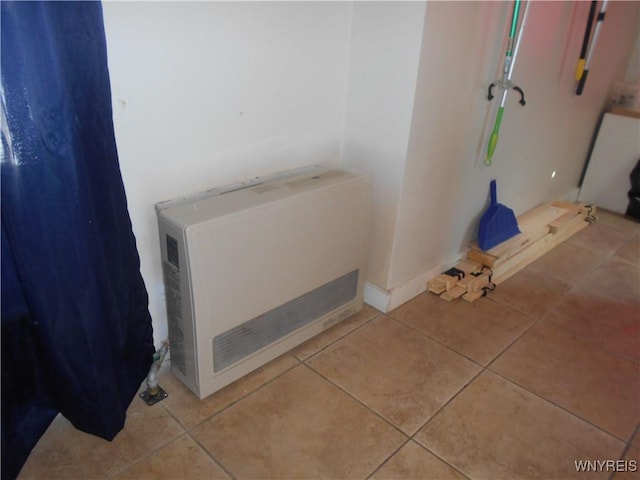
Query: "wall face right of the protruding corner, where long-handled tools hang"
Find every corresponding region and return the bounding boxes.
[387,2,638,288]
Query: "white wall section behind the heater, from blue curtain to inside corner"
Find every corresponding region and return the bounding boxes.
[103,2,351,345]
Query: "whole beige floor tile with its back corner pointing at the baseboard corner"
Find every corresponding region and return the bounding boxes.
[308,316,481,435]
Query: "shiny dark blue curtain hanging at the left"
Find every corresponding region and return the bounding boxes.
[0,0,154,479]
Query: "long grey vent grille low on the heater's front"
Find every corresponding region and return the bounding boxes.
[213,270,359,372]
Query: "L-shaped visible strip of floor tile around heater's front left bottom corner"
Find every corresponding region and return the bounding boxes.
[160,355,298,430]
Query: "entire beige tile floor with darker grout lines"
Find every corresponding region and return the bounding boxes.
[21,212,640,480]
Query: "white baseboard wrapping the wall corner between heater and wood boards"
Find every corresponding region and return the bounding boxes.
[364,251,466,313]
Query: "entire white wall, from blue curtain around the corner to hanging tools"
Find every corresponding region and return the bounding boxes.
[103,1,640,344]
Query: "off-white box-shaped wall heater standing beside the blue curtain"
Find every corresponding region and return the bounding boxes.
[156,166,371,398]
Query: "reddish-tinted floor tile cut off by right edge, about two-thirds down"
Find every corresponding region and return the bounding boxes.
[545,290,640,363]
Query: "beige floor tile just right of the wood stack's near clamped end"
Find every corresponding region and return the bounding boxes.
[489,265,572,319]
